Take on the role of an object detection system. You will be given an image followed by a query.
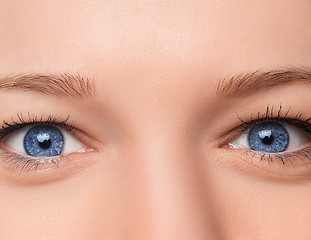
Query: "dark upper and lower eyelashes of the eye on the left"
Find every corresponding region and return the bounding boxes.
[0,112,76,173]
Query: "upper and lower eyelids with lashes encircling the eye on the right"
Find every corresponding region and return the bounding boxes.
[218,105,311,177]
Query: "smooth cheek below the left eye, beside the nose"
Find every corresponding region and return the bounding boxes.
[0,155,126,240]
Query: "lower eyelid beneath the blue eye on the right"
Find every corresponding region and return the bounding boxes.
[216,148,311,183]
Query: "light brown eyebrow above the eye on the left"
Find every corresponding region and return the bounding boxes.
[0,73,95,99]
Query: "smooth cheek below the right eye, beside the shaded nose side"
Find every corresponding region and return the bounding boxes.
[211,164,311,239]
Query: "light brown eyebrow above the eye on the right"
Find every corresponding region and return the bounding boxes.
[216,67,311,97]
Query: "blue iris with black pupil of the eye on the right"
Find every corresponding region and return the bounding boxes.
[248,122,289,153]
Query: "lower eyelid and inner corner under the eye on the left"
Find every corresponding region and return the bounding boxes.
[0,129,97,178]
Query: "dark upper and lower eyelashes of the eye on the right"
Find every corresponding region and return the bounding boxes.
[237,104,311,167]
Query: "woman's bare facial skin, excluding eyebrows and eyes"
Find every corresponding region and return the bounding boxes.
[0,0,311,240]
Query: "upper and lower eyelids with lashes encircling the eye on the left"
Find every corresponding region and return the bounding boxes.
[0,113,97,173]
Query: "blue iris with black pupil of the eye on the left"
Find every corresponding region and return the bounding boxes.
[24,125,64,157]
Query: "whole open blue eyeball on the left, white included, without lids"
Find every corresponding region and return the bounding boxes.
[4,124,83,157]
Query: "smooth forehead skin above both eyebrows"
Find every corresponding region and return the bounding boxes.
[0,0,311,77]
